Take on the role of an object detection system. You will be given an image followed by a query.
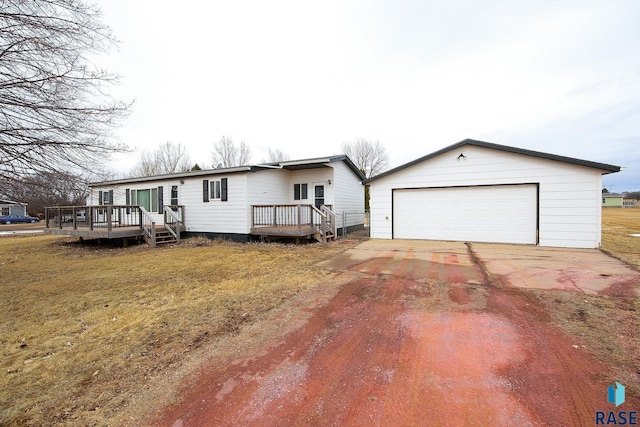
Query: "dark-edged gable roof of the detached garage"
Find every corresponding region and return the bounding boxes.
[364,139,620,184]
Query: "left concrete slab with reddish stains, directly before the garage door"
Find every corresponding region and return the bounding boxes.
[319,239,484,283]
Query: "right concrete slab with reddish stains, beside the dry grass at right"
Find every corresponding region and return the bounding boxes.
[471,243,640,296]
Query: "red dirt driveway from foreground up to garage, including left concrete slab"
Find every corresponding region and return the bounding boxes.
[156,244,640,427]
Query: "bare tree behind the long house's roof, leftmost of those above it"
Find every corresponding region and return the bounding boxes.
[131,141,192,176]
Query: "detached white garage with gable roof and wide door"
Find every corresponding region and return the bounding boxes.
[365,139,620,248]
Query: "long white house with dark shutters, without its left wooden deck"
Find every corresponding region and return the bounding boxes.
[80,155,365,241]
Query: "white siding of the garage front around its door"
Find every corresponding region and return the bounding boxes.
[370,146,602,248]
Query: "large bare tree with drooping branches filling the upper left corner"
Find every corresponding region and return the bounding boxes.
[0,0,129,179]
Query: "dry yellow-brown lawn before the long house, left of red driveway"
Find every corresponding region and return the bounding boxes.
[0,236,353,425]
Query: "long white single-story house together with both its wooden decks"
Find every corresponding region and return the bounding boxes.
[45,155,365,242]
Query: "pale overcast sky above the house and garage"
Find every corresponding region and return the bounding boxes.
[99,0,640,191]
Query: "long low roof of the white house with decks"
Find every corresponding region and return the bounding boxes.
[89,154,366,187]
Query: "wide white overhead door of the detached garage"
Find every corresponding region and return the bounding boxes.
[393,185,537,244]
